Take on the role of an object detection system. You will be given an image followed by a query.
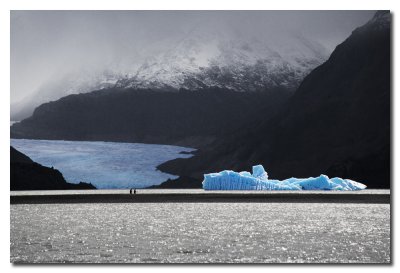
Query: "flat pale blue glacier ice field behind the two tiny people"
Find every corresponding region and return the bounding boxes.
[11,139,194,189]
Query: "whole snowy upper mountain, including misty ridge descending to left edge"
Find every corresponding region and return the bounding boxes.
[11,31,329,121]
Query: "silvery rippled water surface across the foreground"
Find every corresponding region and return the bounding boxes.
[10,203,390,263]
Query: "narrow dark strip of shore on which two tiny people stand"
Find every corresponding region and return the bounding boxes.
[10,192,390,204]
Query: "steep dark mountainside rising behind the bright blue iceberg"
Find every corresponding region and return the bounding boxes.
[159,12,391,188]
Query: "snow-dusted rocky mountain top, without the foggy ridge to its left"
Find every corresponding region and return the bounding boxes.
[116,31,329,92]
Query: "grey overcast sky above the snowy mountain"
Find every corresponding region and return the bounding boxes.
[11,11,374,102]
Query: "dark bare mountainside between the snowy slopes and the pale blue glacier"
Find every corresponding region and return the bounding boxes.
[11,88,287,147]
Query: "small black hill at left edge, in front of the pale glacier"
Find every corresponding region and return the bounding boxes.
[10,147,95,191]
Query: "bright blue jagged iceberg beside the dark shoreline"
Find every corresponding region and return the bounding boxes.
[203,165,367,191]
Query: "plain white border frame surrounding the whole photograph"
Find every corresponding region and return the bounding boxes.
[0,0,400,273]
